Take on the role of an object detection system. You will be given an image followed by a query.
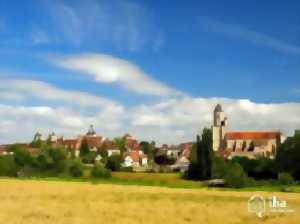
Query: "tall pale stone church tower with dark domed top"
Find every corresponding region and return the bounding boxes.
[212,104,228,151]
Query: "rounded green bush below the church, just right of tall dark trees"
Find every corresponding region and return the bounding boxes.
[224,163,247,188]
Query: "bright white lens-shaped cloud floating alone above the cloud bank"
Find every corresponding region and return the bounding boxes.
[55,54,179,96]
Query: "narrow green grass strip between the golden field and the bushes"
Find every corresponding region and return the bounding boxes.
[0,169,300,193]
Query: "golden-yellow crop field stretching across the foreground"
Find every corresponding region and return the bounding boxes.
[0,179,300,224]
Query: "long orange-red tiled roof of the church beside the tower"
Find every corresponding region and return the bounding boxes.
[225,131,281,139]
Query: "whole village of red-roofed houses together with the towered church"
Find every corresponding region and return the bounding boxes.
[0,104,284,172]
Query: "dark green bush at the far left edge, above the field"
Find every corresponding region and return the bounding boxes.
[0,155,20,177]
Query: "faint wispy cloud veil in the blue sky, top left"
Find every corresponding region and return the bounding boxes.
[38,0,163,51]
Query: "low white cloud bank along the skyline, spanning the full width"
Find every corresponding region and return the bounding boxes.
[0,93,300,144]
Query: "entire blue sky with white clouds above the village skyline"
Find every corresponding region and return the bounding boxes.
[0,0,300,144]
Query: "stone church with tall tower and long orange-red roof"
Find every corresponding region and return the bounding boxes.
[212,104,281,159]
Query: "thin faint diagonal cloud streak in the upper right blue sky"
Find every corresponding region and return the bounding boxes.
[201,18,300,55]
